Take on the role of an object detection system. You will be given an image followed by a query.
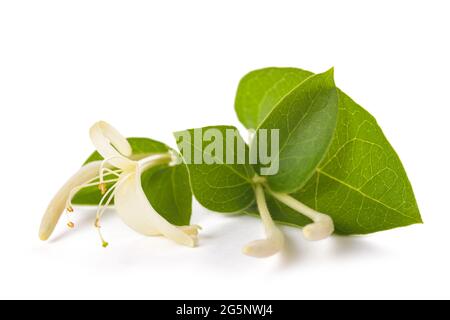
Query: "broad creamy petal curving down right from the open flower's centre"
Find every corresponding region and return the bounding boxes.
[114,169,198,247]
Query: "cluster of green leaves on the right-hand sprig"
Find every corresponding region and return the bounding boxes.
[177,68,422,234]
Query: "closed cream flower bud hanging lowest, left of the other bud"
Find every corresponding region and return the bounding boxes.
[242,184,284,258]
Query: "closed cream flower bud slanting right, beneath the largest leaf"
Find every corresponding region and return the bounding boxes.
[270,191,334,241]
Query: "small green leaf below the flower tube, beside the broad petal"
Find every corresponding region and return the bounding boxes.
[141,164,192,226]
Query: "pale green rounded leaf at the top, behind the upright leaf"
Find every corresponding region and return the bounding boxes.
[235,68,313,129]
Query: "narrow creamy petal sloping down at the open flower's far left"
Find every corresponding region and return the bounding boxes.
[39,161,101,240]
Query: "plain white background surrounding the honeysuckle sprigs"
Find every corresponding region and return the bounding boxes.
[0,0,450,299]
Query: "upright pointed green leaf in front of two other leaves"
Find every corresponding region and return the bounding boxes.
[257,69,338,193]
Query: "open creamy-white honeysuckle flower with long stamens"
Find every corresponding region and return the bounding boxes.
[39,121,200,247]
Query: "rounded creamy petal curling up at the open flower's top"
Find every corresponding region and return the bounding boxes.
[89,121,134,170]
